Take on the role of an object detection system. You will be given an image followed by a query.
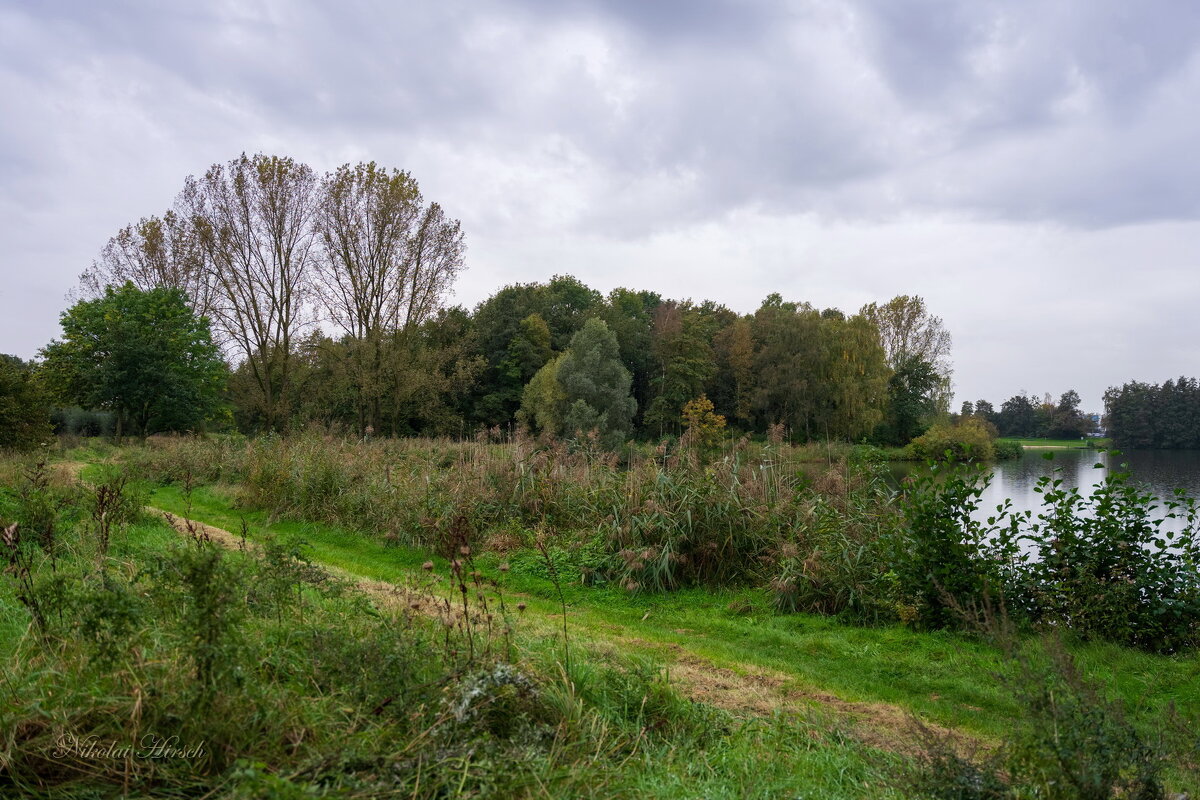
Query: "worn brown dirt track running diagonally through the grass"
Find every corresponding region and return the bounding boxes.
[148,507,988,754]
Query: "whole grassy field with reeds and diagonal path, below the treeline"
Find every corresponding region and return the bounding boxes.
[0,437,1200,798]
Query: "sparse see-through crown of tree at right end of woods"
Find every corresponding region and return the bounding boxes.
[858,295,952,413]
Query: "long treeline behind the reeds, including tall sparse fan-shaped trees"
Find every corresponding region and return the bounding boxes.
[48,155,950,444]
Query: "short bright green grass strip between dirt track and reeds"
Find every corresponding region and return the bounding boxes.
[151,487,1200,738]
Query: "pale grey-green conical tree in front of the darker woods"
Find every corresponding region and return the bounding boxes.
[557,318,637,450]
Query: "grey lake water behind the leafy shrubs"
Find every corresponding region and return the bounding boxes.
[979,449,1200,530]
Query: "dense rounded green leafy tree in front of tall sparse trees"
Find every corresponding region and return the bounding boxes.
[42,283,227,437]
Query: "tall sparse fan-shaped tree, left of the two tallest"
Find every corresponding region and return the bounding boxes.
[184,154,320,429]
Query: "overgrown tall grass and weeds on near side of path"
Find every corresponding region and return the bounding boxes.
[0,453,907,799]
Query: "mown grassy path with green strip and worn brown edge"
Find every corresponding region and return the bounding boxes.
[142,487,1200,750]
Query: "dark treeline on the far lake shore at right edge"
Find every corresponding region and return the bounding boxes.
[1104,377,1200,450]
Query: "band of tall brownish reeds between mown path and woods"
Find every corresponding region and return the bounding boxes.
[131,434,894,610]
